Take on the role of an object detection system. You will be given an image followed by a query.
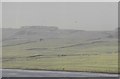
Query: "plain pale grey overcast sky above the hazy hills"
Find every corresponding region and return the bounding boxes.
[2,2,118,30]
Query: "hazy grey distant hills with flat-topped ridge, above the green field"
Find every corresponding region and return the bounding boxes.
[2,26,117,45]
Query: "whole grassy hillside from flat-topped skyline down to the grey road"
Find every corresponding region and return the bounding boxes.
[2,27,118,73]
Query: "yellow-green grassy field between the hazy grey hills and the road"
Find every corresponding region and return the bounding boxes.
[2,39,118,73]
